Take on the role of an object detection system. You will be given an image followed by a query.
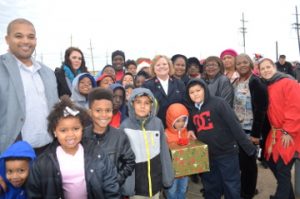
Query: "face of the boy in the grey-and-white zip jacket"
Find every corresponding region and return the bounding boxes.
[133,96,152,118]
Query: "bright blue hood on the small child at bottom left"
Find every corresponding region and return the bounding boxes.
[0,141,36,192]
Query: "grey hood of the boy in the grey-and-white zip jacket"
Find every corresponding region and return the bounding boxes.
[127,88,157,121]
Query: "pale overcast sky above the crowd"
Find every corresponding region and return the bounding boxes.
[0,0,300,70]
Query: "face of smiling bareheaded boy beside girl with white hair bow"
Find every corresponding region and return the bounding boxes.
[89,99,113,133]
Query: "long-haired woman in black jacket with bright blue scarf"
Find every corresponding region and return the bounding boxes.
[54,47,87,97]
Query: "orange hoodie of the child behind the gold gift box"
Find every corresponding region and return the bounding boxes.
[165,103,189,143]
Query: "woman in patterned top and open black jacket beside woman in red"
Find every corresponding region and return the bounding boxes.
[233,54,268,199]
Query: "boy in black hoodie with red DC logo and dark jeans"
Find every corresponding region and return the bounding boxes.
[187,79,256,199]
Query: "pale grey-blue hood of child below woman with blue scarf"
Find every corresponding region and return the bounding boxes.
[71,73,96,102]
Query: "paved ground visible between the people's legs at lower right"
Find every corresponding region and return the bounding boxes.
[187,160,300,199]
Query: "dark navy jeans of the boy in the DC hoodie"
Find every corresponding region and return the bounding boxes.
[201,154,241,199]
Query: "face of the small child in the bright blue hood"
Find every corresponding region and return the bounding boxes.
[5,160,29,188]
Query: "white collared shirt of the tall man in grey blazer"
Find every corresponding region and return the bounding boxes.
[16,58,52,148]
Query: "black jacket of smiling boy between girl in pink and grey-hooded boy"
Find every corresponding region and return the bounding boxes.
[83,125,135,186]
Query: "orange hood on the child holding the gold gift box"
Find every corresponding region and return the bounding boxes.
[166,103,189,132]
